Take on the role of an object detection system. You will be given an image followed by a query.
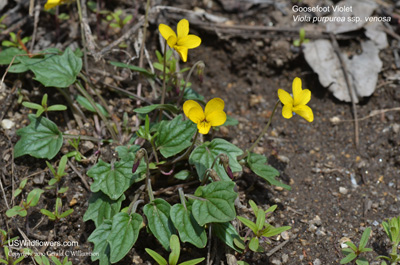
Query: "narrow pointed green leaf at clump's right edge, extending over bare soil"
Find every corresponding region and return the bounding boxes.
[247,153,291,190]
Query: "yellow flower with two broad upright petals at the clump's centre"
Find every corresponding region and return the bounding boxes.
[183,98,226,134]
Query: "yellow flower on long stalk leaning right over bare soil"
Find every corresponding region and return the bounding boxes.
[278,77,314,122]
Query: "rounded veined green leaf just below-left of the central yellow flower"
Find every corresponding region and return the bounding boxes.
[156,115,197,158]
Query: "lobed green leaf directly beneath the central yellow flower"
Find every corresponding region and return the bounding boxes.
[189,138,243,180]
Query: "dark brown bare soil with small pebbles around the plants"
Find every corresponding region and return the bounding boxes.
[0,0,400,265]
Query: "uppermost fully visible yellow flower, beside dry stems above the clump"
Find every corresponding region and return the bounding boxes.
[158,19,201,62]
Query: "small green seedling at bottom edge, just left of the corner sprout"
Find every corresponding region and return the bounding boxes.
[340,227,372,265]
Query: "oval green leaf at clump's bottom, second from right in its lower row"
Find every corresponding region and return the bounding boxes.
[170,203,207,248]
